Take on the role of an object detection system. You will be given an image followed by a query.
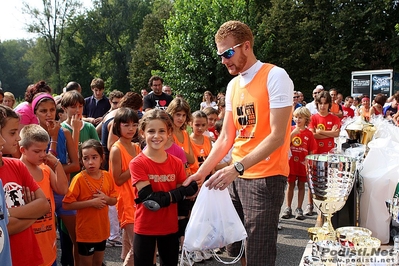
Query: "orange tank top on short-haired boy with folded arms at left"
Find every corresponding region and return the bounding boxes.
[32,164,57,266]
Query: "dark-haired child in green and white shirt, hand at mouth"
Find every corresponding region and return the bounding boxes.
[60,91,100,150]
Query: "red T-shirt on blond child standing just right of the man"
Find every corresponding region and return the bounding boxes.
[290,126,317,176]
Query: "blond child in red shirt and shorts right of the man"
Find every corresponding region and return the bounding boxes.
[281,107,317,220]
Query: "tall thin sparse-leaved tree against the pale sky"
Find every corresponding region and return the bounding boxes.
[24,0,81,92]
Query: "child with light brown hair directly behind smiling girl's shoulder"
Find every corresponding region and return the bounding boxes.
[166,98,195,168]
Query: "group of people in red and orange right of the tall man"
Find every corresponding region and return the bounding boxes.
[281,85,399,226]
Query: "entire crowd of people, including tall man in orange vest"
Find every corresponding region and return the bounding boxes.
[0,18,399,266]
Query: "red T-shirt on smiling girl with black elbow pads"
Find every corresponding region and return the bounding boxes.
[129,153,186,235]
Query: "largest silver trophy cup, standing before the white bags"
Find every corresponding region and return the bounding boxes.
[306,154,356,240]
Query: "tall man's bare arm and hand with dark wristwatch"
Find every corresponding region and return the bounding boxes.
[208,106,292,190]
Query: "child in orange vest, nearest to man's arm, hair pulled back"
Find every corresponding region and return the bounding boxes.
[190,110,213,174]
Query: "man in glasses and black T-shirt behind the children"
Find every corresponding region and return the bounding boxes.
[143,76,173,111]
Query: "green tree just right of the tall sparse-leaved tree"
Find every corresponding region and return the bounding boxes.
[65,0,151,93]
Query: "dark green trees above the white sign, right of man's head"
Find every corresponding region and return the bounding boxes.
[259,0,399,96]
